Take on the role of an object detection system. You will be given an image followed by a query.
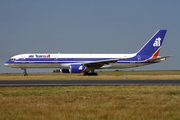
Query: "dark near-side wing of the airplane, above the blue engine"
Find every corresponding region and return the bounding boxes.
[83,59,120,68]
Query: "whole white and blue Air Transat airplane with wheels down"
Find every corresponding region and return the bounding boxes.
[4,30,172,76]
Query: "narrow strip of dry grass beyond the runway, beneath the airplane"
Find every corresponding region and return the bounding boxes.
[0,70,180,80]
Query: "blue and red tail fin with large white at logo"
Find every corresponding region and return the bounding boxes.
[137,30,167,58]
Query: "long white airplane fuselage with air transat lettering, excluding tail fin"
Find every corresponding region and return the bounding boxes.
[4,53,153,69]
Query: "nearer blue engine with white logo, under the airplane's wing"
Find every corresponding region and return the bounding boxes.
[69,64,88,73]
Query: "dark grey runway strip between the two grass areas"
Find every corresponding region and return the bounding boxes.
[0,80,180,87]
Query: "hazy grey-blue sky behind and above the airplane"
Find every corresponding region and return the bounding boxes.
[0,0,180,73]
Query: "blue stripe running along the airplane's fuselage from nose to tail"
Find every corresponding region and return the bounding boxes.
[6,55,156,64]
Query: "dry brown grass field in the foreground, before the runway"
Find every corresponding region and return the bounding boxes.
[0,86,180,120]
